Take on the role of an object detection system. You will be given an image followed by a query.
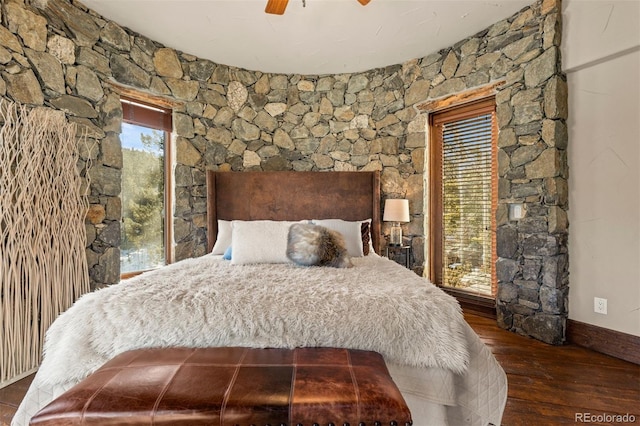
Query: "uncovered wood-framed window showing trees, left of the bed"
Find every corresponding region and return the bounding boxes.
[120,98,172,277]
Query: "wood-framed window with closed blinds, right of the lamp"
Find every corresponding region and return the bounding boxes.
[429,98,497,297]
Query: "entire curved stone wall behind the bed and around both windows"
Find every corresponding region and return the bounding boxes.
[0,0,568,343]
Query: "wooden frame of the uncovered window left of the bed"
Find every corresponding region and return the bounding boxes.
[120,96,174,279]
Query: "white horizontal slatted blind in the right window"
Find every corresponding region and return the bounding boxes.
[441,108,495,295]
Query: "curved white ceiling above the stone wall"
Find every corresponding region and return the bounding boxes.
[83,0,533,74]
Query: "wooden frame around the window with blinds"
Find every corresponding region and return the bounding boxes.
[428,96,498,302]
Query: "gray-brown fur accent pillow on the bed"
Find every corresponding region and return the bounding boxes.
[287,223,353,268]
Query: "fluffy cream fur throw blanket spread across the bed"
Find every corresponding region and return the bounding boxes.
[38,255,469,386]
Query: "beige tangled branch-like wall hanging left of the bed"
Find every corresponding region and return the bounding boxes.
[0,100,89,388]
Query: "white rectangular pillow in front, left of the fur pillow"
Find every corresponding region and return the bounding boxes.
[231,220,300,265]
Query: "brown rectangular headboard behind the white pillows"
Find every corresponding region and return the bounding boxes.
[207,170,381,253]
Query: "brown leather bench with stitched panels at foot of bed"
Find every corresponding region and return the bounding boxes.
[30,347,411,426]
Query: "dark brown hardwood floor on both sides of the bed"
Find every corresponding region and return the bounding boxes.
[0,314,640,426]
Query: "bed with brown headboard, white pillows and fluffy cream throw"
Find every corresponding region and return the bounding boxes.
[12,171,507,426]
